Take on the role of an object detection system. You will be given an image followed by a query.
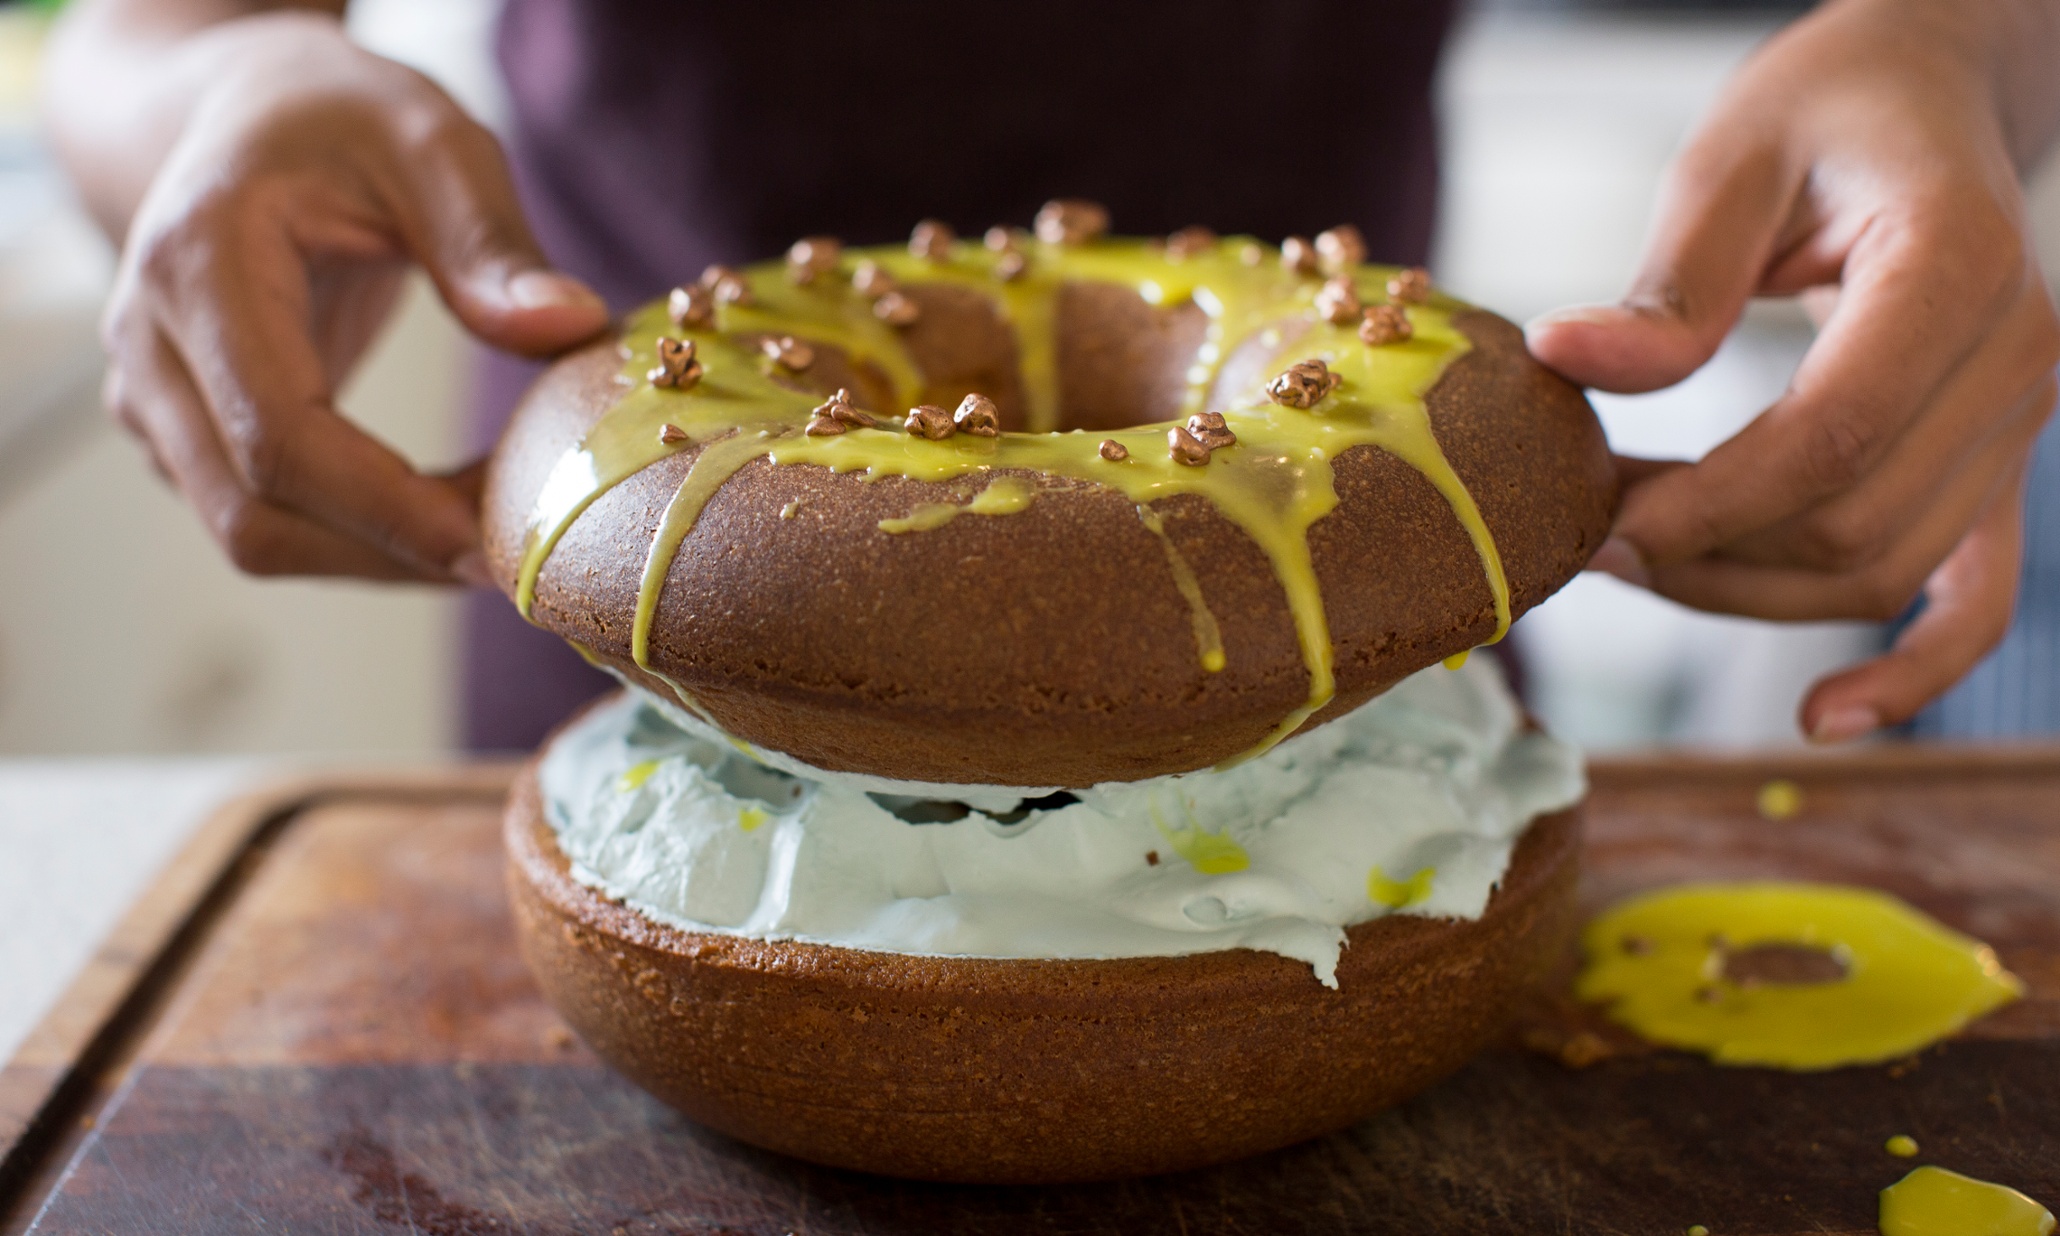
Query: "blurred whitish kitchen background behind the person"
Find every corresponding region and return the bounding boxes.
[0,0,2060,754]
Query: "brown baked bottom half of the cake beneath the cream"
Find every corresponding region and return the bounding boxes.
[507,766,1580,1182]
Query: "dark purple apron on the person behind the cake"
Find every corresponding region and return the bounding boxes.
[464,0,1452,750]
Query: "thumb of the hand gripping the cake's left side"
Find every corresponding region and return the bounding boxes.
[393,126,608,356]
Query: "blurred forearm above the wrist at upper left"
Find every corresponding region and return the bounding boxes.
[43,0,344,241]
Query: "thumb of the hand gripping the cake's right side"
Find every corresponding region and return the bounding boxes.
[1524,127,1792,393]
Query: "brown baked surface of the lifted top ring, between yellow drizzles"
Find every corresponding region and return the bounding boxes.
[484,284,1615,787]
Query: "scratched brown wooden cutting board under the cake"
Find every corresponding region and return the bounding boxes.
[0,748,2060,1236]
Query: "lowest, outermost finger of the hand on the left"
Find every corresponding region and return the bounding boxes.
[107,325,443,581]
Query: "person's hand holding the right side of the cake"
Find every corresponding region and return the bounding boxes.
[1529,0,2060,742]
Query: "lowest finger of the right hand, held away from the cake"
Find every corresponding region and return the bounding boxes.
[1800,455,2025,742]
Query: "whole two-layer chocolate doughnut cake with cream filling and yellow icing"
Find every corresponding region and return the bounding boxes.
[484,202,1615,1182]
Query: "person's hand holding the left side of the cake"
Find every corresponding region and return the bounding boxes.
[103,14,608,583]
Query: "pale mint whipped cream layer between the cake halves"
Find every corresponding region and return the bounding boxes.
[540,657,1586,987]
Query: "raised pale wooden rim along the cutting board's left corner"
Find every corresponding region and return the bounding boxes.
[0,760,519,1215]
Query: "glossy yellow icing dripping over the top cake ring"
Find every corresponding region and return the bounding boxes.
[515,237,1510,762]
